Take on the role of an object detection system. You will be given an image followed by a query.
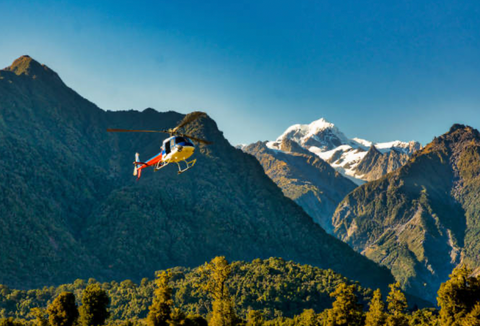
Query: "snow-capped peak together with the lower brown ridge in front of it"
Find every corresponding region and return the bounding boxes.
[239,119,421,233]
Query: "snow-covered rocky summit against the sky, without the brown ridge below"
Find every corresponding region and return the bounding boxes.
[267,118,421,185]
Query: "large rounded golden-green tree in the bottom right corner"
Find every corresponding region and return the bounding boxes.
[437,266,480,326]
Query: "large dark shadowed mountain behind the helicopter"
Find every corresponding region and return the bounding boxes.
[0,56,392,288]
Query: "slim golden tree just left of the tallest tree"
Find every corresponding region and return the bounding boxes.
[147,270,173,326]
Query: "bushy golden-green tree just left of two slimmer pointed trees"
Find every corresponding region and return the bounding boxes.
[326,283,363,326]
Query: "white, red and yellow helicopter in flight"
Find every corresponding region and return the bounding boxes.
[107,111,212,180]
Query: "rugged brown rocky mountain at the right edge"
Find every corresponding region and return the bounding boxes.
[333,125,480,299]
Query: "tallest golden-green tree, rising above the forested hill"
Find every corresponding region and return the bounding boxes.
[202,257,238,326]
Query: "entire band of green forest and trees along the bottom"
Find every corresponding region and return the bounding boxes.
[0,257,480,326]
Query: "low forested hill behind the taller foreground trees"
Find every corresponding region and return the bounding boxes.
[0,258,372,320]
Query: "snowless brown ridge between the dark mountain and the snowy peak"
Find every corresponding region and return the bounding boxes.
[242,138,356,233]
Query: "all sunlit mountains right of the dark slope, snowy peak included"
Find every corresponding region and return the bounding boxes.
[242,109,480,301]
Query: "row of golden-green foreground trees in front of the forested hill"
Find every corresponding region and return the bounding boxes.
[0,257,480,326]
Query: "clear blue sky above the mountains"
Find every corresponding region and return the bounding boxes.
[0,0,480,144]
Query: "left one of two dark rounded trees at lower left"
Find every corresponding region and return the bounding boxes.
[47,292,78,326]
